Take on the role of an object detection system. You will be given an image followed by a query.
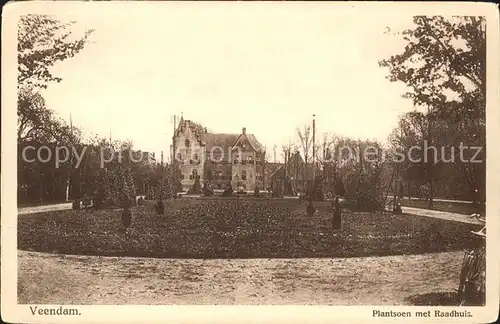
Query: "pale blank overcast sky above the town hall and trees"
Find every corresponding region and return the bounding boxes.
[40,5,413,159]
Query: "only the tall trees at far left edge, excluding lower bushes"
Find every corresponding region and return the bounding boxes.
[17,14,93,204]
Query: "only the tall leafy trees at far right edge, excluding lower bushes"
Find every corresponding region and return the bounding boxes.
[380,16,486,207]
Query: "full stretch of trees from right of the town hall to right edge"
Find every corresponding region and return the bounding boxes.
[282,16,486,208]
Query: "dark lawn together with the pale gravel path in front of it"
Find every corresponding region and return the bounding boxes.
[18,200,477,305]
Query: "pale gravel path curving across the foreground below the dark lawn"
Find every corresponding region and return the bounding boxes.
[18,251,463,305]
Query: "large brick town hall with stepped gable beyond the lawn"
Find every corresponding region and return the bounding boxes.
[172,118,265,190]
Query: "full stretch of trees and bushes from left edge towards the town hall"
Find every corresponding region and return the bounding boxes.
[17,15,178,207]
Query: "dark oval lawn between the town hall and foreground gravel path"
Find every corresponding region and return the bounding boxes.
[18,198,478,259]
